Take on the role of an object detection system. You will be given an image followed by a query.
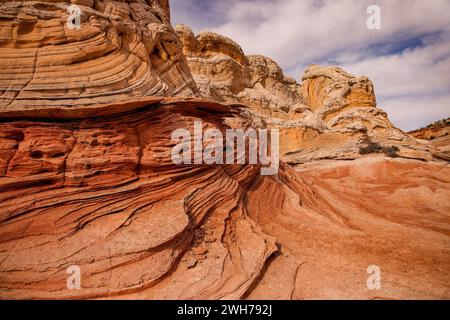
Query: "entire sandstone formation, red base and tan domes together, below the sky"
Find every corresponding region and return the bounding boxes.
[0,0,450,299]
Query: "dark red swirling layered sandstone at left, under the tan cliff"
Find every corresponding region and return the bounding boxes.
[0,100,276,298]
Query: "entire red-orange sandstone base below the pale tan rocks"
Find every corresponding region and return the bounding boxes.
[0,98,450,299]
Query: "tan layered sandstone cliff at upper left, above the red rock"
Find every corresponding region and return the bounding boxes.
[0,0,196,110]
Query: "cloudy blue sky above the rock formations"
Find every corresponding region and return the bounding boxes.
[170,0,450,130]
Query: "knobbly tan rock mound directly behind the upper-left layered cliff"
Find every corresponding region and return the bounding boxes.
[175,25,302,117]
